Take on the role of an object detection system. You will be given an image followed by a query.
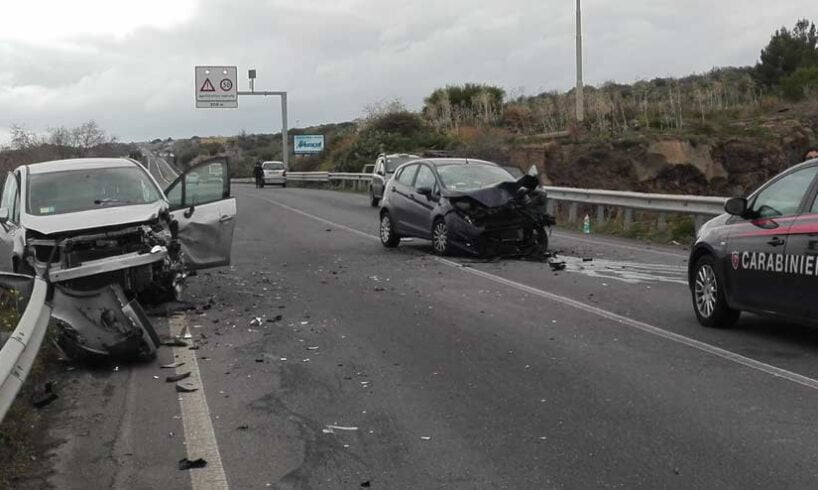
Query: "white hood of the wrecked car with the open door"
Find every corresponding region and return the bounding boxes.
[22,200,168,235]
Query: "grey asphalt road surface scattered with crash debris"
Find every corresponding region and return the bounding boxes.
[29,186,818,488]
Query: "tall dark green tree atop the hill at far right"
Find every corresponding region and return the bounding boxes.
[756,19,818,88]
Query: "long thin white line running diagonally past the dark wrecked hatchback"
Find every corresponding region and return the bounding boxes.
[242,189,818,390]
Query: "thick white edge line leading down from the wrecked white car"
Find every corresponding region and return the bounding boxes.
[168,314,230,490]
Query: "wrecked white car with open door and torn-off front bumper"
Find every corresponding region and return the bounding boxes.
[0,158,236,358]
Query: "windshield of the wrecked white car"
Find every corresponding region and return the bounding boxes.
[28,167,161,216]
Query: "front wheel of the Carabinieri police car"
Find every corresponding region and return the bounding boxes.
[691,255,741,328]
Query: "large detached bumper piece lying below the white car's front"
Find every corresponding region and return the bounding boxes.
[51,283,161,359]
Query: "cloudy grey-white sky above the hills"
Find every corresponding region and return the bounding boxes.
[0,0,818,144]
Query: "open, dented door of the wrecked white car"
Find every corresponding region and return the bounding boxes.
[165,157,236,270]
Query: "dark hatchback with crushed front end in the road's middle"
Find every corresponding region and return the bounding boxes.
[380,158,554,257]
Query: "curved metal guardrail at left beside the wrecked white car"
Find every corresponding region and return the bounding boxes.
[0,274,51,422]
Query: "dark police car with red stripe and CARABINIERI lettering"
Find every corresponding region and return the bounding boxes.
[688,159,818,327]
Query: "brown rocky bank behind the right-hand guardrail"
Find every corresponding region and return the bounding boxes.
[502,104,818,195]
